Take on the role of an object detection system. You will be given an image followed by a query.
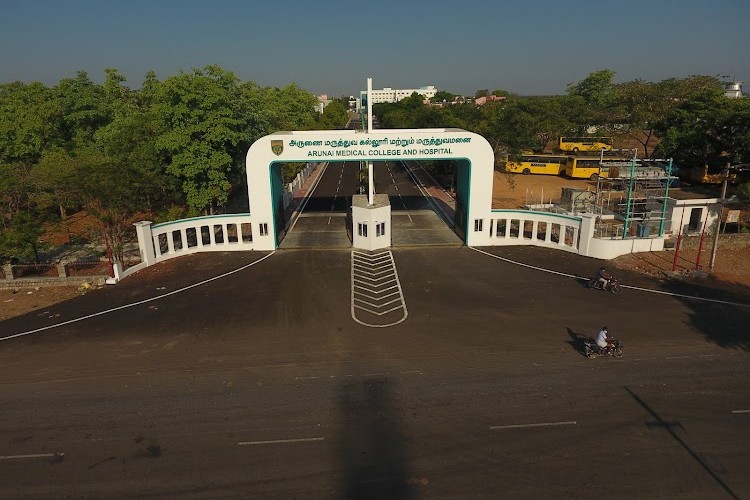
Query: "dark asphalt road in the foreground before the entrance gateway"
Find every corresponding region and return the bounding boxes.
[0,244,750,499]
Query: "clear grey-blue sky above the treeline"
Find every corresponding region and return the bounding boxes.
[0,0,750,95]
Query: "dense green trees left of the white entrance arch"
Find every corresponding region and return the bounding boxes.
[0,66,324,260]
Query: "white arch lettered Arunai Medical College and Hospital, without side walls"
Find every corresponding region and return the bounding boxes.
[246,129,494,250]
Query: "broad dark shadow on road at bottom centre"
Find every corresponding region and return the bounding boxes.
[337,377,417,500]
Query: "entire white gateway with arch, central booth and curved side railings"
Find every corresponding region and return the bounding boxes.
[122,125,665,281]
